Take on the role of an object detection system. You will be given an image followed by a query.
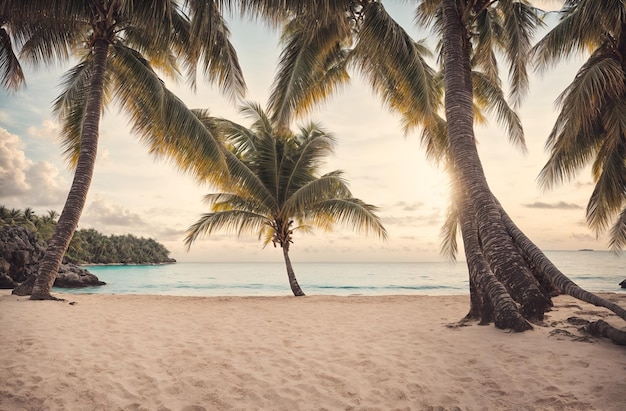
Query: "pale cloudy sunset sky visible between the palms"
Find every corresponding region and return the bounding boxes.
[0,1,607,262]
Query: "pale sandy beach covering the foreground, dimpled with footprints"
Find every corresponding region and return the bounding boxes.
[0,290,626,411]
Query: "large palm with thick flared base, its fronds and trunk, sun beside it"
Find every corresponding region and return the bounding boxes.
[234,0,626,331]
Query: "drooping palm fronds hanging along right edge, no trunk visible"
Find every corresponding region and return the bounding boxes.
[533,0,626,252]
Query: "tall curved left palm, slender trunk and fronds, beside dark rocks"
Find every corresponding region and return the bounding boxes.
[4,0,245,299]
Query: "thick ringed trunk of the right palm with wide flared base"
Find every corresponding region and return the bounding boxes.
[442,0,626,344]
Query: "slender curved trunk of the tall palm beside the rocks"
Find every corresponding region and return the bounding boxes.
[30,40,109,300]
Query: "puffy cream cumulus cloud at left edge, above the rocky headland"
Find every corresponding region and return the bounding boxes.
[0,128,66,207]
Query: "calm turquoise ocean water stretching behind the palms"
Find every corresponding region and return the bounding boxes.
[55,251,626,296]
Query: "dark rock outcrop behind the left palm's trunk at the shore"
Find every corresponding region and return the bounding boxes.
[0,226,105,295]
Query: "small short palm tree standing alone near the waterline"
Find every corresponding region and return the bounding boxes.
[185,103,387,296]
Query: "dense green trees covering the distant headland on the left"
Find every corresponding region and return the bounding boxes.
[0,205,173,264]
